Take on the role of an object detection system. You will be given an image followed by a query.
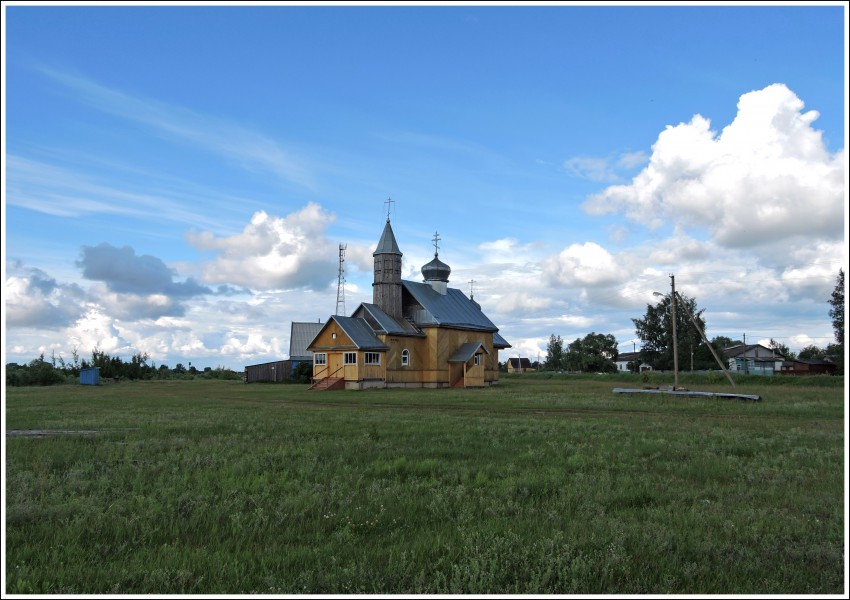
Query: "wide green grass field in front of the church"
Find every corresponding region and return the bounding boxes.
[5,375,846,594]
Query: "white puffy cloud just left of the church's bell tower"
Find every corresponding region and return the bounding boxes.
[188,202,339,290]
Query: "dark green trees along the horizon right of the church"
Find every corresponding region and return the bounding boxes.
[541,269,844,375]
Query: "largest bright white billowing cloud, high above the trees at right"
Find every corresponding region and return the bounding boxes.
[584,84,846,248]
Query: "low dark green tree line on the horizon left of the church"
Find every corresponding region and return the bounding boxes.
[6,348,242,386]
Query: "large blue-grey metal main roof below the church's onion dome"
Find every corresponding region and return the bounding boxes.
[401,280,500,332]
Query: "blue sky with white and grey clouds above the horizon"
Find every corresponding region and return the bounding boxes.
[2,2,848,370]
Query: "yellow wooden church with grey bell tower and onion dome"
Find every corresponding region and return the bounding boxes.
[307,216,511,390]
